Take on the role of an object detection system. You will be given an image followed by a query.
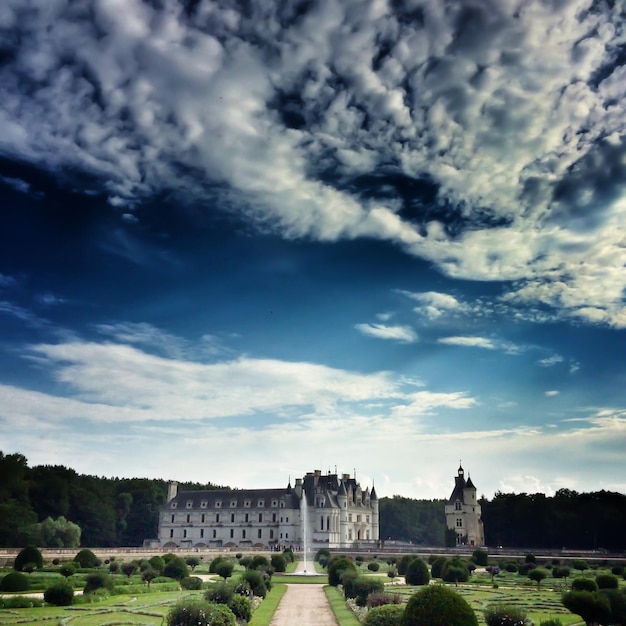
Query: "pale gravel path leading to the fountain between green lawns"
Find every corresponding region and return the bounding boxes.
[270,561,337,626]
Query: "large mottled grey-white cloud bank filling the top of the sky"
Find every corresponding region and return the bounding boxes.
[0,0,626,328]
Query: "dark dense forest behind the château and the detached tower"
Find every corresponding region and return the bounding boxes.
[0,452,626,551]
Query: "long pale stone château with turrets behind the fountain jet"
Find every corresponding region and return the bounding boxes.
[158,470,379,549]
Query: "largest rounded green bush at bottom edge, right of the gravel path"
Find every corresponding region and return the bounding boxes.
[401,585,478,626]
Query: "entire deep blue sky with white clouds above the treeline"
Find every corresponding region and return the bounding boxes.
[0,0,626,499]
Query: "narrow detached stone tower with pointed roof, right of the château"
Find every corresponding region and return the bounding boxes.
[445,465,485,546]
